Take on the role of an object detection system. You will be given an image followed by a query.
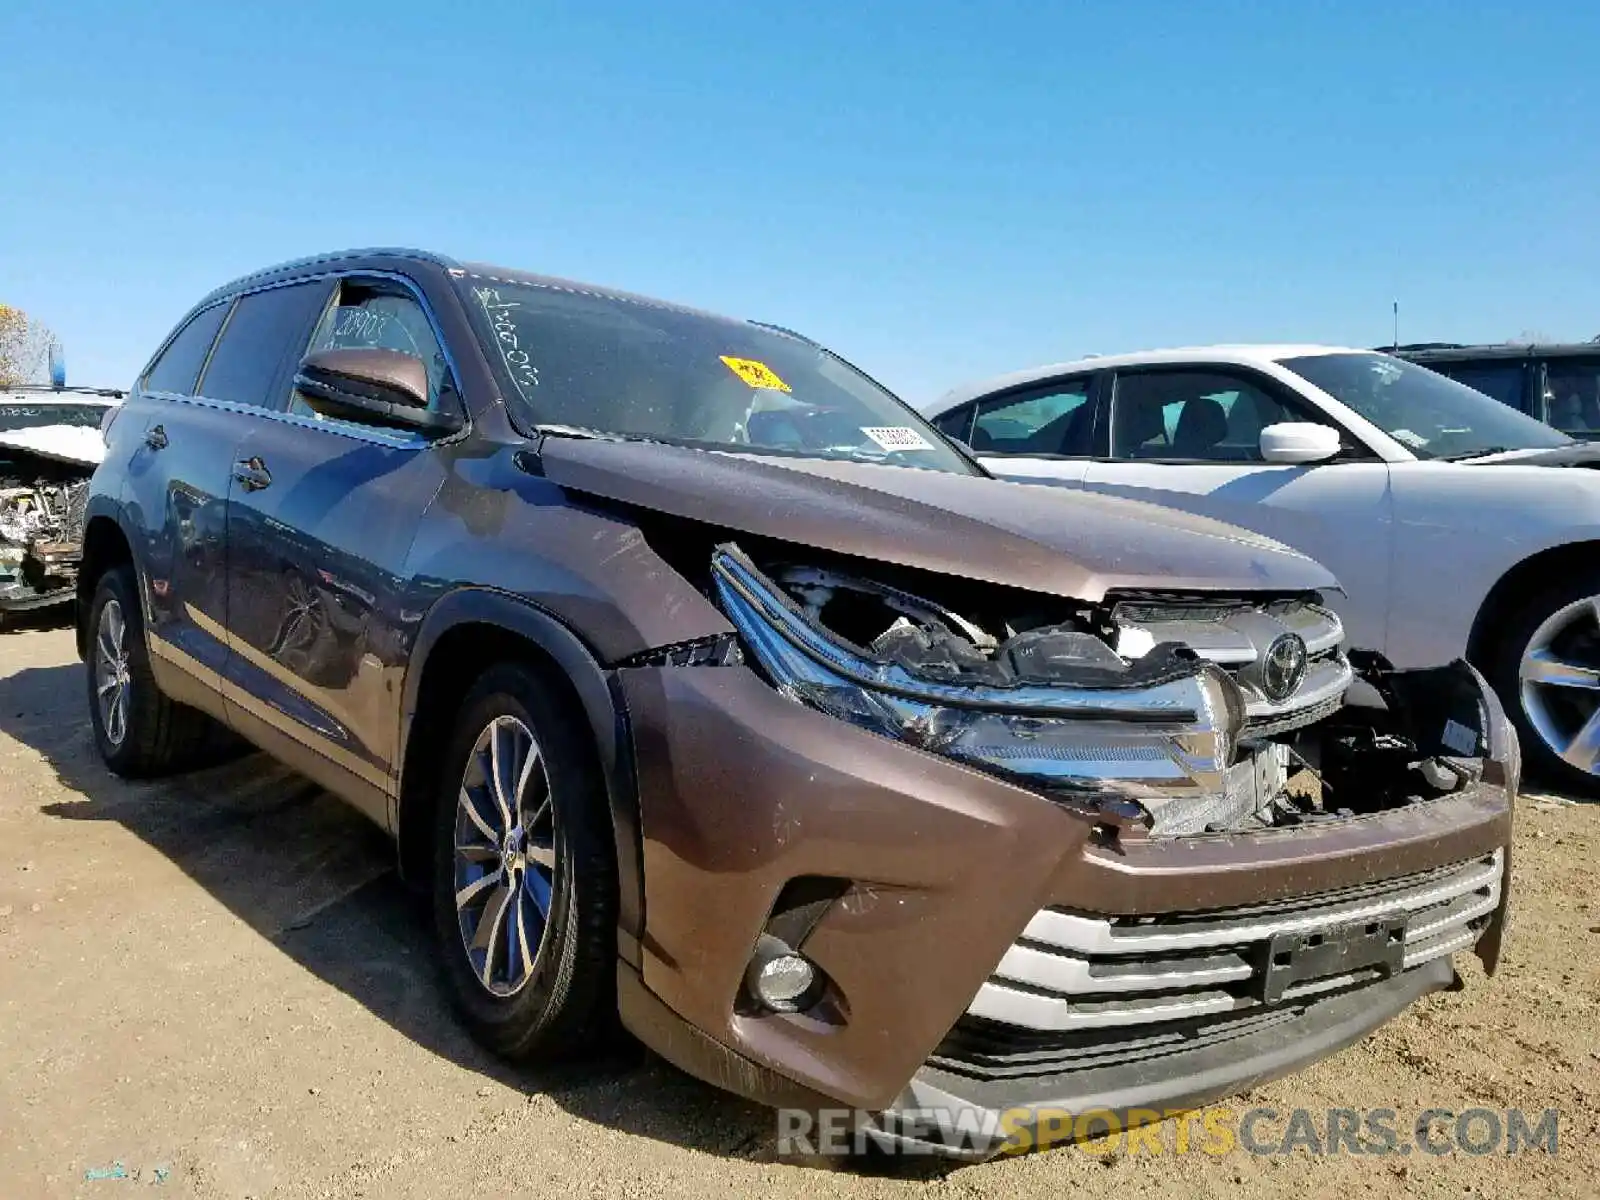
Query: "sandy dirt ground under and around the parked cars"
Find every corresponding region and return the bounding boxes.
[0,629,1600,1200]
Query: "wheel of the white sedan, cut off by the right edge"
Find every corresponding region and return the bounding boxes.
[1485,571,1600,795]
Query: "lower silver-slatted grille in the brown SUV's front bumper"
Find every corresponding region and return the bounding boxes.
[968,851,1504,1032]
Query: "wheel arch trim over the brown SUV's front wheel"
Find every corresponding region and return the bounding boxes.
[390,587,643,962]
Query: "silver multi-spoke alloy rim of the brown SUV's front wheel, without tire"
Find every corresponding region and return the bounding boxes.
[453,717,555,997]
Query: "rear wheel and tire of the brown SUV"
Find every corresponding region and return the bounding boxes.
[86,566,229,779]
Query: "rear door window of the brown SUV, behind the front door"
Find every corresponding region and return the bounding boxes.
[198,282,328,408]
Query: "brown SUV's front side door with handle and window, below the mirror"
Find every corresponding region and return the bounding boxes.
[227,277,459,824]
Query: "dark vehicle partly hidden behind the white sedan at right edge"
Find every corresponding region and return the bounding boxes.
[1389,342,1600,440]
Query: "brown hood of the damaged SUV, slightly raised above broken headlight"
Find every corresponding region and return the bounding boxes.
[539,437,1338,602]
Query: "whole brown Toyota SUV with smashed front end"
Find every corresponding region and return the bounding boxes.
[78,251,1517,1157]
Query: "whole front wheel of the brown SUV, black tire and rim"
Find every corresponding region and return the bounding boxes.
[432,664,616,1061]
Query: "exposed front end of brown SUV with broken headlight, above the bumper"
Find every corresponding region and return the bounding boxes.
[712,542,1491,838]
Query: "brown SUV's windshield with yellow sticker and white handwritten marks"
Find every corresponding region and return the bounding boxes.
[462,275,978,475]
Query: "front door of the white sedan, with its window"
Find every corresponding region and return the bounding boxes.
[1083,366,1394,650]
